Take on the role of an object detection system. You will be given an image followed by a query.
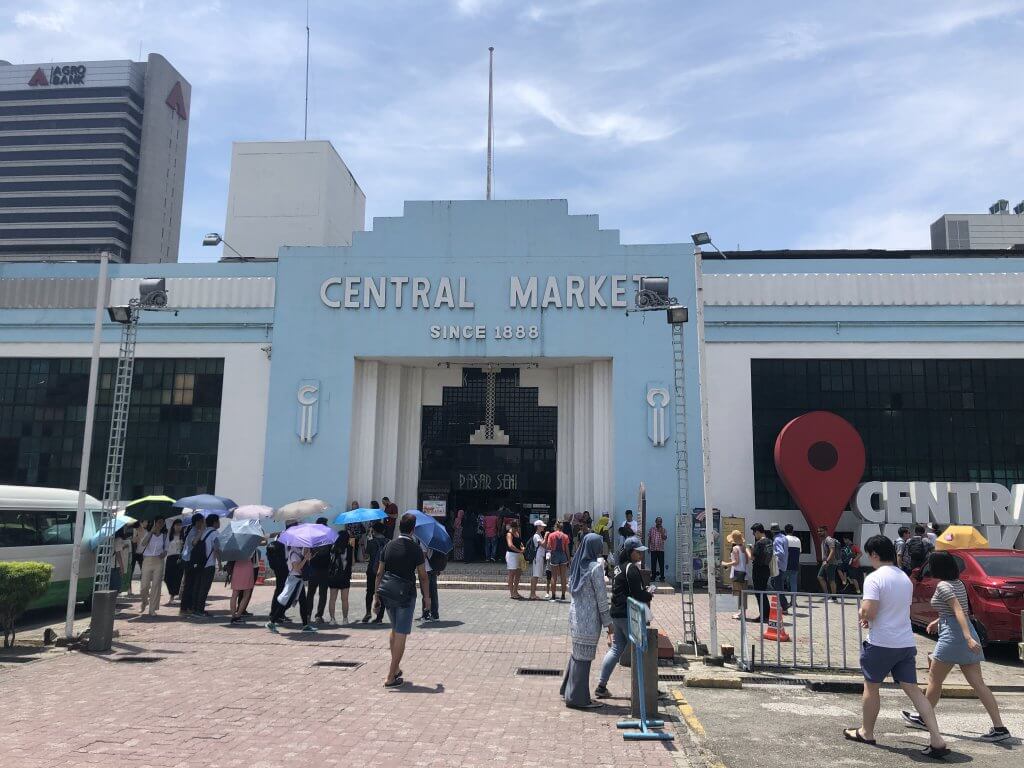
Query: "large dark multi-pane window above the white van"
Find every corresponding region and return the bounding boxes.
[0,357,223,501]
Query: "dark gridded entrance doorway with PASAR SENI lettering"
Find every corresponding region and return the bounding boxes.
[419,368,558,561]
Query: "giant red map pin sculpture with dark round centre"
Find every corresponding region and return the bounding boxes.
[775,411,864,553]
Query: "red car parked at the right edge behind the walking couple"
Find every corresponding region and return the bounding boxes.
[910,549,1024,645]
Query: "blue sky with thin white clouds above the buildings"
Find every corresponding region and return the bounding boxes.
[0,0,1024,261]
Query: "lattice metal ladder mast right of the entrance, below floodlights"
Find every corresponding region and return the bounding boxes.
[672,324,697,653]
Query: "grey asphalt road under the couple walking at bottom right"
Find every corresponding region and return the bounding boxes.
[683,685,1024,768]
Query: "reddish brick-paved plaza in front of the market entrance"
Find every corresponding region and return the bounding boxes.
[0,585,685,768]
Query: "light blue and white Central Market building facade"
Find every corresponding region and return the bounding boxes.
[0,201,1024,581]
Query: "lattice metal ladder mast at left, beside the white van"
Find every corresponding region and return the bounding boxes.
[92,299,139,592]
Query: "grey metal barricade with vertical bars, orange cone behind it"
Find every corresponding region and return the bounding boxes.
[738,590,864,672]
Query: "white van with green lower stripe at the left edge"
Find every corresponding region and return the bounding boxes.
[0,485,103,608]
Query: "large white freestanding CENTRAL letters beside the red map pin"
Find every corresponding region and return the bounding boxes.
[850,481,1024,549]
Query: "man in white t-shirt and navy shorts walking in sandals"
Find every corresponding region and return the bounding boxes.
[843,536,949,759]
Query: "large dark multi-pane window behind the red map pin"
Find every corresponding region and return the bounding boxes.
[751,359,1024,509]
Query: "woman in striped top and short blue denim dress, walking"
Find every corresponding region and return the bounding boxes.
[905,552,1010,741]
